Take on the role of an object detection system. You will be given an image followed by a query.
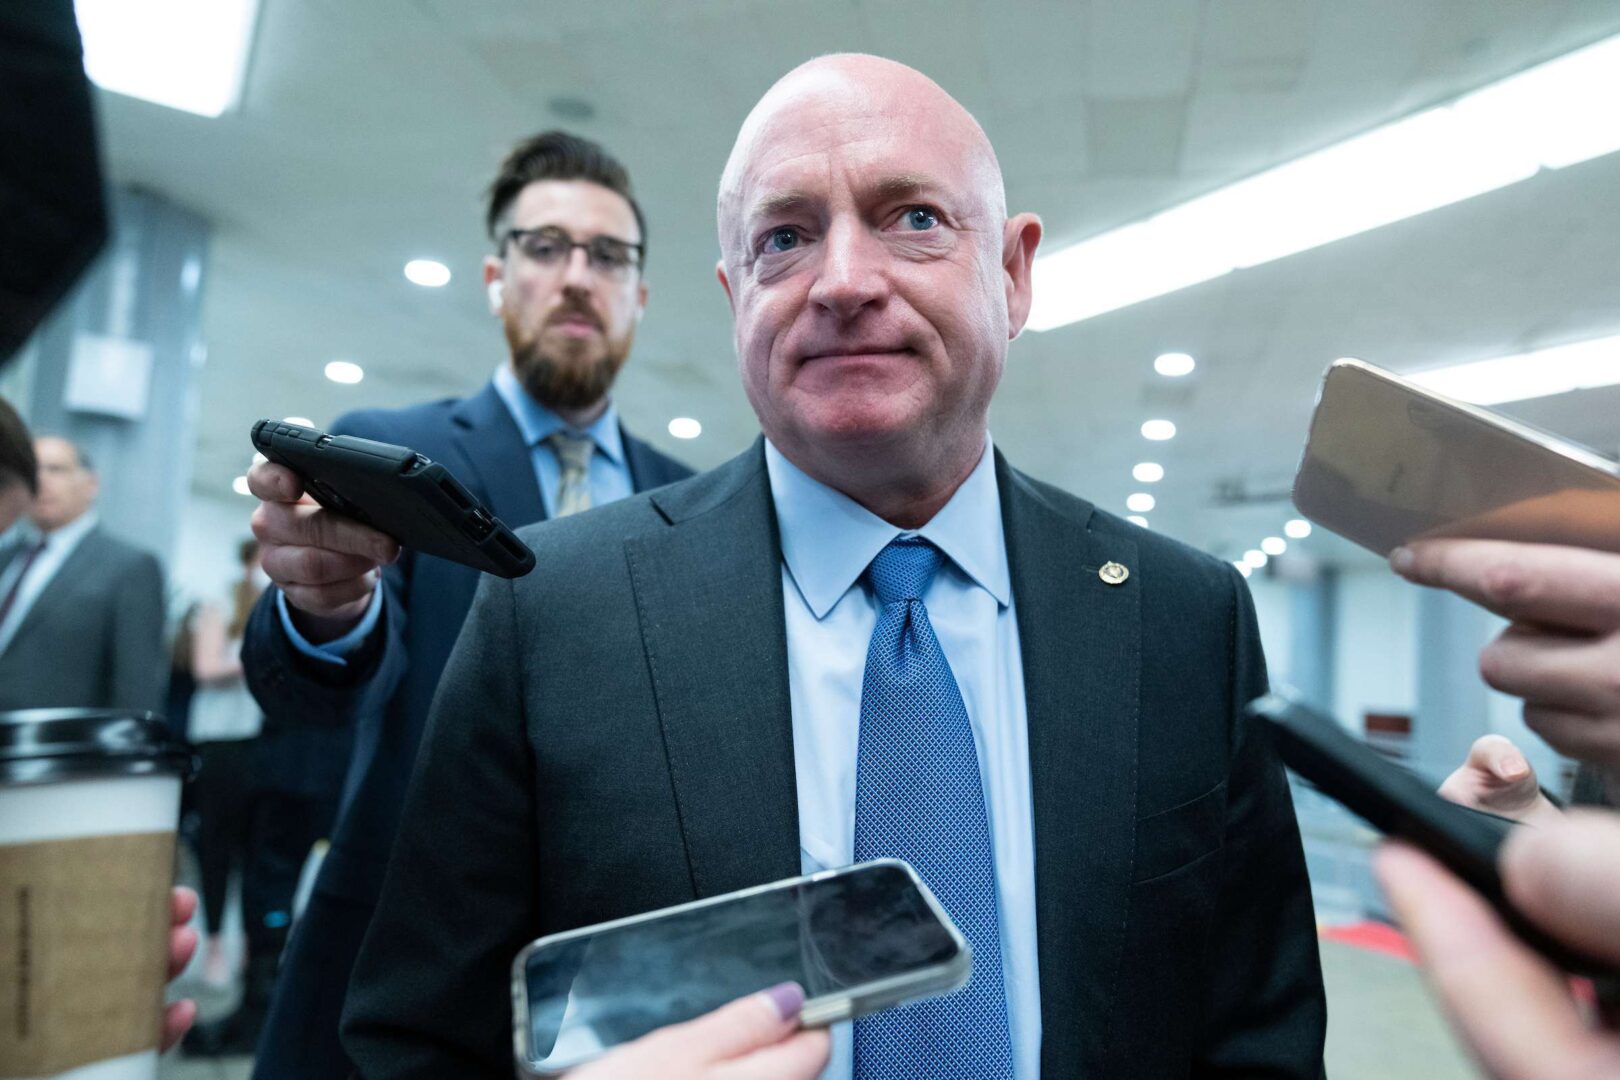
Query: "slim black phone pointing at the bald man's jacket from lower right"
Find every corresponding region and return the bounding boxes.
[1246,693,1617,980]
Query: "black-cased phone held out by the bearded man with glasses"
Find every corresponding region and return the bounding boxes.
[253,419,535,578]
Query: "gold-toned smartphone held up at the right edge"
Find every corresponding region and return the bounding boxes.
[1294,359,1620,555]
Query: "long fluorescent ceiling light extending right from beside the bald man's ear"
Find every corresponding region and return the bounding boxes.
[1029,36,1620,330]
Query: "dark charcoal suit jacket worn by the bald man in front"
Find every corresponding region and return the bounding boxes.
[343,445,1327,1080]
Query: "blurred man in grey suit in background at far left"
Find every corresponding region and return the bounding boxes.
[0,436,167,709]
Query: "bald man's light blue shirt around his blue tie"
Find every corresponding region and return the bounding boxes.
[765,437,1040,1080]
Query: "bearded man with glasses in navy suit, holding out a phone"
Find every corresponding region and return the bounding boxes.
[228,131,692,1080]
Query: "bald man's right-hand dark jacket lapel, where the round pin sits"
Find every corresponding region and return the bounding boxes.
[996,455,1140,1077]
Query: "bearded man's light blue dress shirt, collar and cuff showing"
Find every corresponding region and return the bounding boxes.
[275,364,635,664]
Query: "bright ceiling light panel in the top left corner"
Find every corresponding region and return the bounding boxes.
[73,0,259,117]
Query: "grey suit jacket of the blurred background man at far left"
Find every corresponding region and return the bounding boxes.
[0,525,168,709]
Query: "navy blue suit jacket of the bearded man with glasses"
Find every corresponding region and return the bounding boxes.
[241,384,692,1080]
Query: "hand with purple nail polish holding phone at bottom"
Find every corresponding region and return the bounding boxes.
[569,983,831,1080]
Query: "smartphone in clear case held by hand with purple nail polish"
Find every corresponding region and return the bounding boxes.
[512,858,972,1077]
